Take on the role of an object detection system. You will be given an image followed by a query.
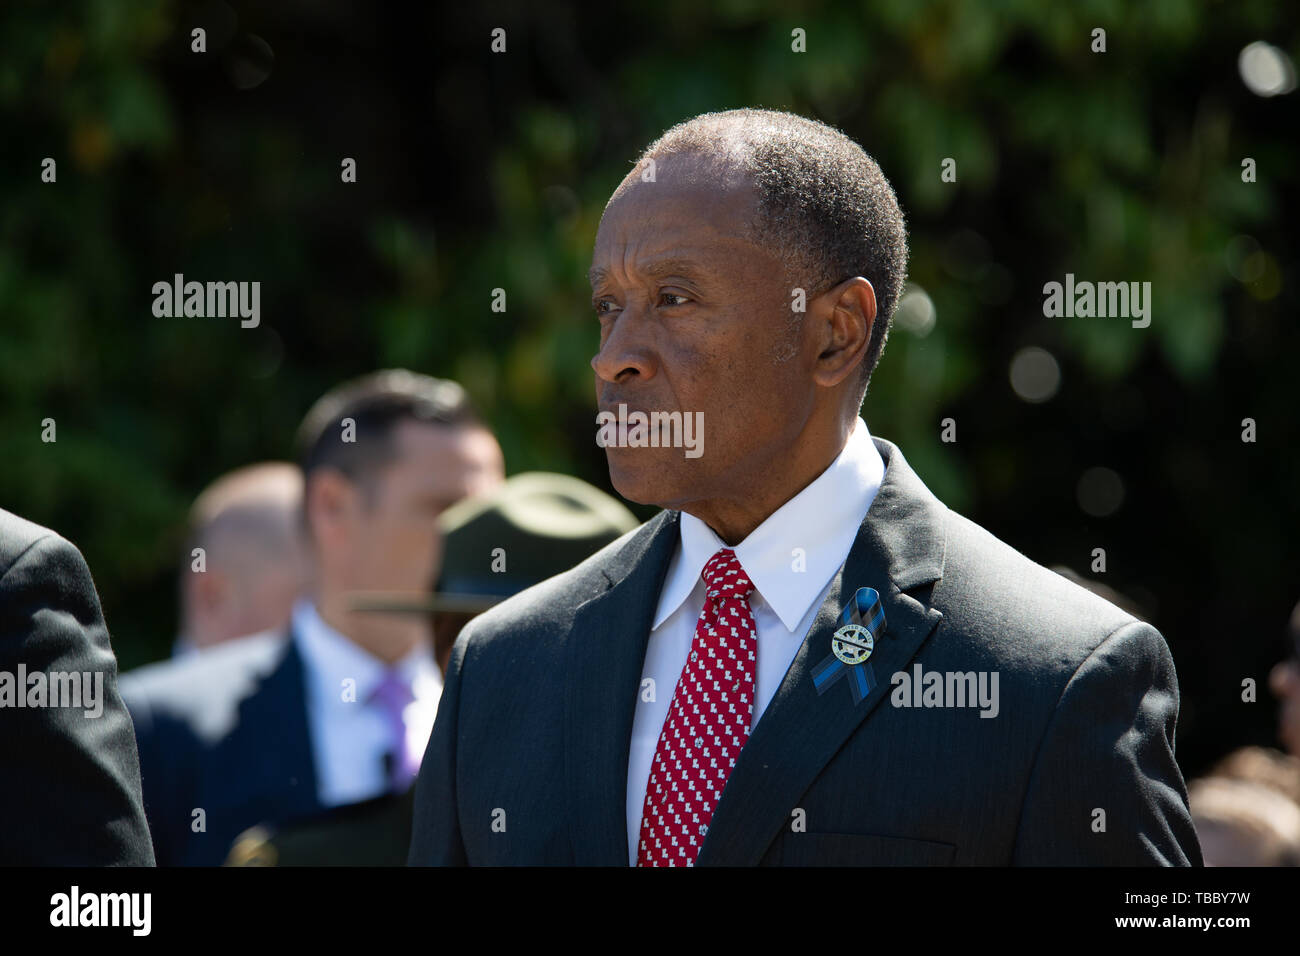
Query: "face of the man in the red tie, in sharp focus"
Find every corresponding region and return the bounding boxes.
[592,156,815,511]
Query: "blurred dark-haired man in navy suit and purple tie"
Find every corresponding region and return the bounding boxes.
[122,369,504,865]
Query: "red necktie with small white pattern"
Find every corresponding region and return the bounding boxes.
[637,548,758,866]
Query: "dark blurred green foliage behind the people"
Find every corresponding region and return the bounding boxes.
[0,0,1300,773]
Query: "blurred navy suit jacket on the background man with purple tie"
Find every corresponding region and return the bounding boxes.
[121,636,322,866]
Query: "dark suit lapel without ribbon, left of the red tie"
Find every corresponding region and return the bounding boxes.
[564,511,677,866]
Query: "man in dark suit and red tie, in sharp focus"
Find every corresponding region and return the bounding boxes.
[410,111,1201,865]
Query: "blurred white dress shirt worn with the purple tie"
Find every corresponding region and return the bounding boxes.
[293,600,442,806]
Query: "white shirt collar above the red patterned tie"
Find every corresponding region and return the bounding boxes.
[651,418,885,633]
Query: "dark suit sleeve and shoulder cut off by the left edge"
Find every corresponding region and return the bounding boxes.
[0,510,153,866]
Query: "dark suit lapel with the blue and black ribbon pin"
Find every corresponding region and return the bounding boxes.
[696,438,946,866]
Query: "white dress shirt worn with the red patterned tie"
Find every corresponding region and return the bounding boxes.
[627,418,885,866]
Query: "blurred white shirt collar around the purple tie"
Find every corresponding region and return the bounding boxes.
[291,598,442,702]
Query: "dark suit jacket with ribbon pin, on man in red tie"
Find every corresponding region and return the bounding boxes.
[410,438,1201,866]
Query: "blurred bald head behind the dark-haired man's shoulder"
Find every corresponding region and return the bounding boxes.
[181,462,306,649]
